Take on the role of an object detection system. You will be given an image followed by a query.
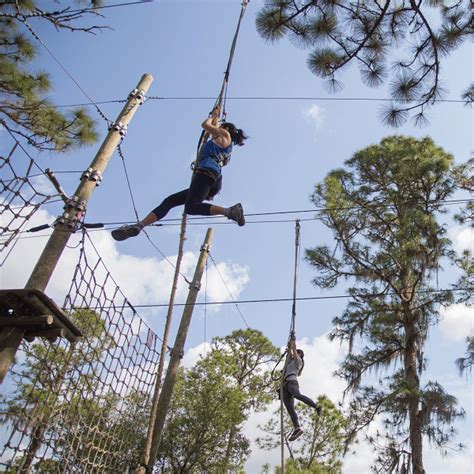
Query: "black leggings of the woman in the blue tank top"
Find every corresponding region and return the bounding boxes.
[151,172,216,220]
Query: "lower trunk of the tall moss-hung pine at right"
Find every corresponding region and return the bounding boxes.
[405,312,425,474]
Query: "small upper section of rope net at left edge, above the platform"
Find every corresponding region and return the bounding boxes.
[0,141,61,266]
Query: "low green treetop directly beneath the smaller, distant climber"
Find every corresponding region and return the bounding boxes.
[257,395,352,473]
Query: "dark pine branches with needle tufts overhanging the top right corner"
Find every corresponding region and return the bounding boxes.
[256,0,472,126]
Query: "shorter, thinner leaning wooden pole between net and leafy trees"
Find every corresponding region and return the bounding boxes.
[145,228,213,472]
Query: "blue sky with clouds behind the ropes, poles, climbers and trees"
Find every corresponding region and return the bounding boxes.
[2,0,473,473]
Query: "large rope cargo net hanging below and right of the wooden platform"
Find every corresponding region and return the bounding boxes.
[0,230,161,473]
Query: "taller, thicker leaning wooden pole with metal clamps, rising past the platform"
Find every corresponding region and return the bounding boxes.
[0,74,153,383]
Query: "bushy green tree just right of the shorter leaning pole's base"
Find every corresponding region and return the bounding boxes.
[158,365,249,472]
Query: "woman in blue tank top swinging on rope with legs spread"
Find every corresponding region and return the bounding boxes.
[112,106,247,240]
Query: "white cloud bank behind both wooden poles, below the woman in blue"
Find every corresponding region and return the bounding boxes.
[0,206,249,312]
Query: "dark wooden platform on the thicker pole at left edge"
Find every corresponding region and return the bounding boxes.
[0,289,82,342]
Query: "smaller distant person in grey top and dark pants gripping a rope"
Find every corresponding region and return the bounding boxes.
[282,332,321,441]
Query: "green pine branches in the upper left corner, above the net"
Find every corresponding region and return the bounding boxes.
[0,0,101,152]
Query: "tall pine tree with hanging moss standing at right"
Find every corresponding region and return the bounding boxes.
[306,136,463,474]
